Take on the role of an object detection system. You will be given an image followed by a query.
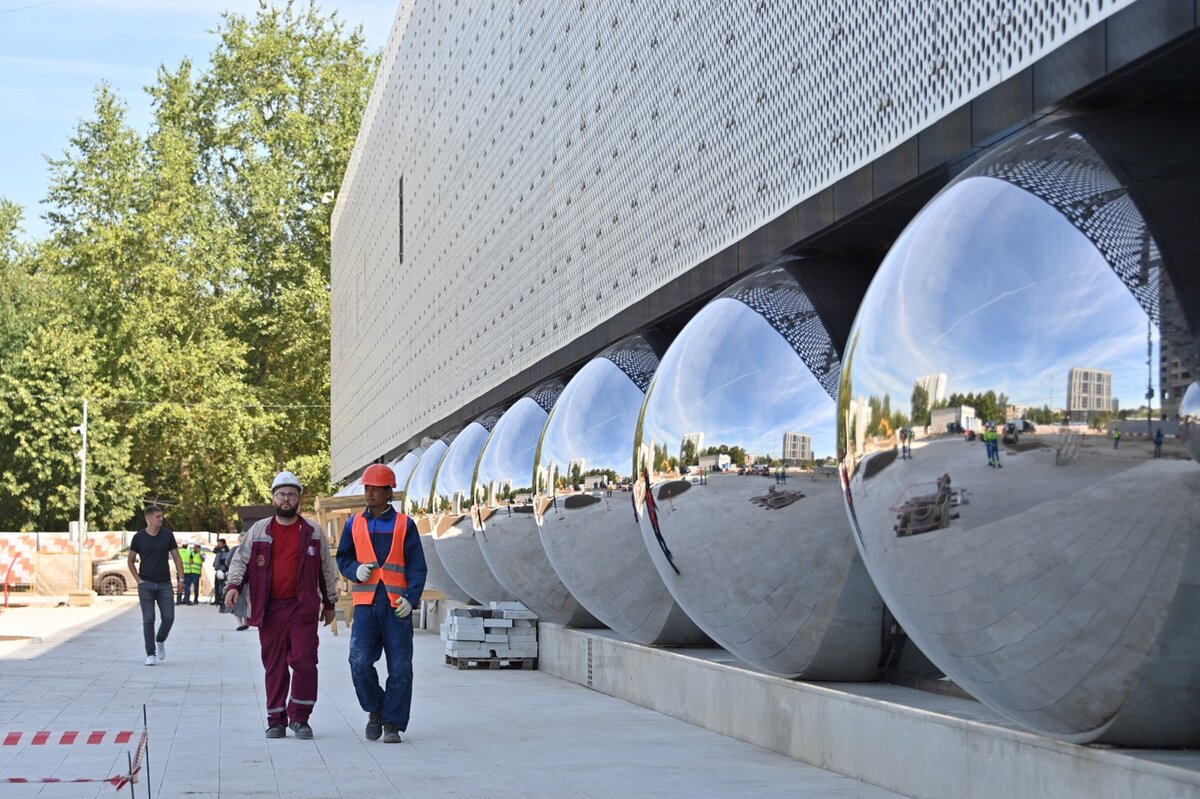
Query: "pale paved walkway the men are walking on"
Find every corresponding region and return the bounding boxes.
[0,597,896,799]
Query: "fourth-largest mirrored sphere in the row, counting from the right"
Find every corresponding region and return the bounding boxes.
[474,378,599,627]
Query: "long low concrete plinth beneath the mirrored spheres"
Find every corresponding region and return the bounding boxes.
[538,623,1200,799]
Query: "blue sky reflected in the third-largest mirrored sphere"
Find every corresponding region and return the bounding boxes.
[541,358,646,477]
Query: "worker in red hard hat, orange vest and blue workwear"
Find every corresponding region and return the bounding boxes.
[337,463,426,744]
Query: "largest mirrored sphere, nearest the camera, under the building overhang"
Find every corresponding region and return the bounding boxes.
[839,126,1200,745]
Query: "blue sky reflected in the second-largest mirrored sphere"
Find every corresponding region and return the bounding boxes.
[642,298,835,458]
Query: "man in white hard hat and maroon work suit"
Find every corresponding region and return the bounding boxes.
[226,471,337,740]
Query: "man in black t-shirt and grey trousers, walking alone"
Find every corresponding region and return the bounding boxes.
[126,505,184,666]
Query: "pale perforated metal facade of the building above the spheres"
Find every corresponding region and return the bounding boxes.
[332,0,1132,476]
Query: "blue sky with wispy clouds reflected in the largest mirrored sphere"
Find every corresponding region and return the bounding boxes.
[853,178,1158,411]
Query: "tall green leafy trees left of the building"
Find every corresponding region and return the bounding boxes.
[0,2,378,529]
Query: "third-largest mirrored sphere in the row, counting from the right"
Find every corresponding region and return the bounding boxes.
[534,336,709,645]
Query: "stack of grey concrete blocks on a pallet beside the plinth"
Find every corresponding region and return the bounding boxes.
[442,602,538,661]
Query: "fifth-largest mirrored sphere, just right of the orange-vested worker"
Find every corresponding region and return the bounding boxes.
[431,408,516,605]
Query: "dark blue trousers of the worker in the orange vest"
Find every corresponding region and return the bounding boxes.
[350,590,413,732]
